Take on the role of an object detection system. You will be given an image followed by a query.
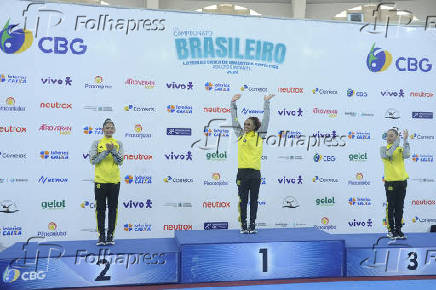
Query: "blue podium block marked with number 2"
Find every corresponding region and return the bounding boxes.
[0,239,179,289]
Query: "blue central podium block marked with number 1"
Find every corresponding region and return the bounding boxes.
[175,228,345,283]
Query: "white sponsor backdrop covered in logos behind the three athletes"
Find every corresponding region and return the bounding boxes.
[0,0,436,247]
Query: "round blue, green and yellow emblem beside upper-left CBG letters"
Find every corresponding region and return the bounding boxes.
[0,20,33,54]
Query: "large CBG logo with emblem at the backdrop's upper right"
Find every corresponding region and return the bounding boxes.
[366,43,432,72]
